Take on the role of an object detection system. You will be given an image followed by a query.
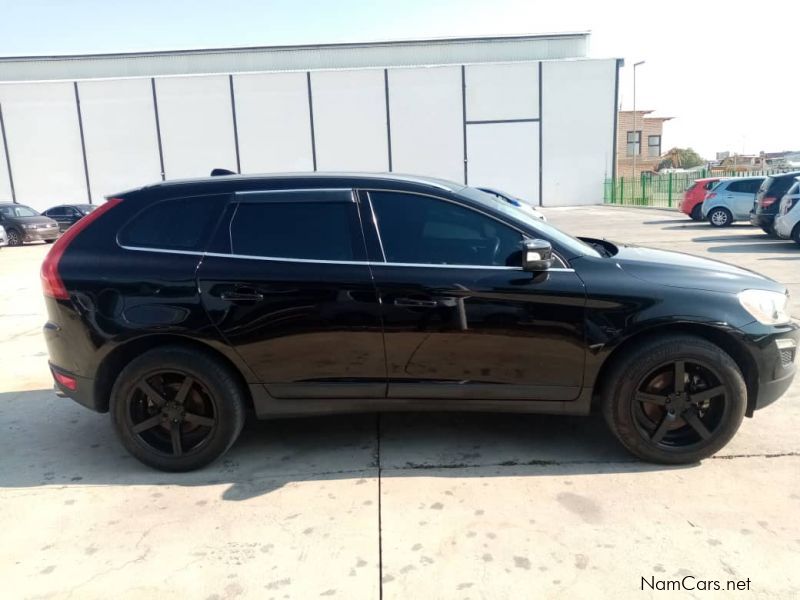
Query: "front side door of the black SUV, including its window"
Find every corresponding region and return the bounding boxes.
[362,191,585,401]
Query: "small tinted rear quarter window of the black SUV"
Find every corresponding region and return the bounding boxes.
[118,195,228,250]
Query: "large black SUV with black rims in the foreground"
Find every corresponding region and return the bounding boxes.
[42,174,799,471]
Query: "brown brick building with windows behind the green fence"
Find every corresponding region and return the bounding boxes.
[617,110,672,177]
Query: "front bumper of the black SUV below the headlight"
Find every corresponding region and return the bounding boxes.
[745,323,800,416]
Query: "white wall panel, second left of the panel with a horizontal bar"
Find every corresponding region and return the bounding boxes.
[311,70,389,171]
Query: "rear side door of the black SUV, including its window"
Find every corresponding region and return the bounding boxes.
[198,189,386,398]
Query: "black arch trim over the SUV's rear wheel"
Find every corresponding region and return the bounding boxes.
[94,334,253,412]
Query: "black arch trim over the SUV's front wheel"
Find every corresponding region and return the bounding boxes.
[592,323,758,417]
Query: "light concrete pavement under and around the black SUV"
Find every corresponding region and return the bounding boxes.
[0,207,800,600]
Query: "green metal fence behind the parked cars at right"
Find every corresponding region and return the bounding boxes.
[603,169,780,208]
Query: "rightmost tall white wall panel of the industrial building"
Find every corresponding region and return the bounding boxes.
[542,60,616,206]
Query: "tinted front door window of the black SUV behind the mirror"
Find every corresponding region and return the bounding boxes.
[370,192,522,266]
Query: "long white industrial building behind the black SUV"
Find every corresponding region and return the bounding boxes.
[0,32,621,209]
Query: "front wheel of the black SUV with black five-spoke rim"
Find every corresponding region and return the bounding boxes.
[601,335,747,465]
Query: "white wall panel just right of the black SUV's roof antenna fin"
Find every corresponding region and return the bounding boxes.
[233,73,314,173]
